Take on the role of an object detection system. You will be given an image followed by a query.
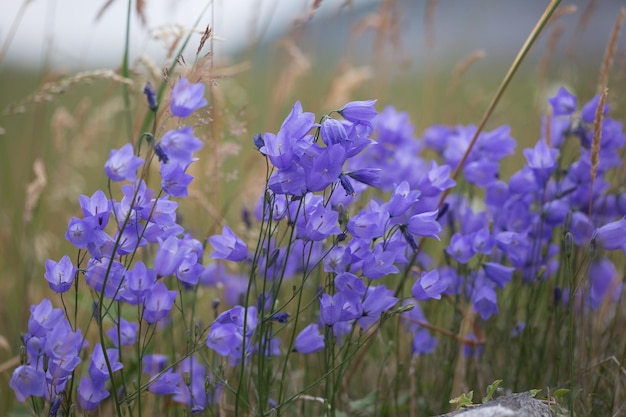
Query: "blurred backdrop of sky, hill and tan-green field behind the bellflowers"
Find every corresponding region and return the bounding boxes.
[0,0,626,415]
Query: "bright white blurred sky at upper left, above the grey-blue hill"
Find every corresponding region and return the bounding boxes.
[0,0,375,69]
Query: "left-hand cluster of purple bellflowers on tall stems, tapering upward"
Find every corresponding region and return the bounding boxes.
[10,78,208,415]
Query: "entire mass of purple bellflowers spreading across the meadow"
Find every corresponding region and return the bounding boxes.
[11,78,626,414]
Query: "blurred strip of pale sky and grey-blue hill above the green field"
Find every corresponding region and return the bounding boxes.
[0,0,626,70]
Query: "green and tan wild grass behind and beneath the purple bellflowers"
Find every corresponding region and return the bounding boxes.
[0,1,626,416]
